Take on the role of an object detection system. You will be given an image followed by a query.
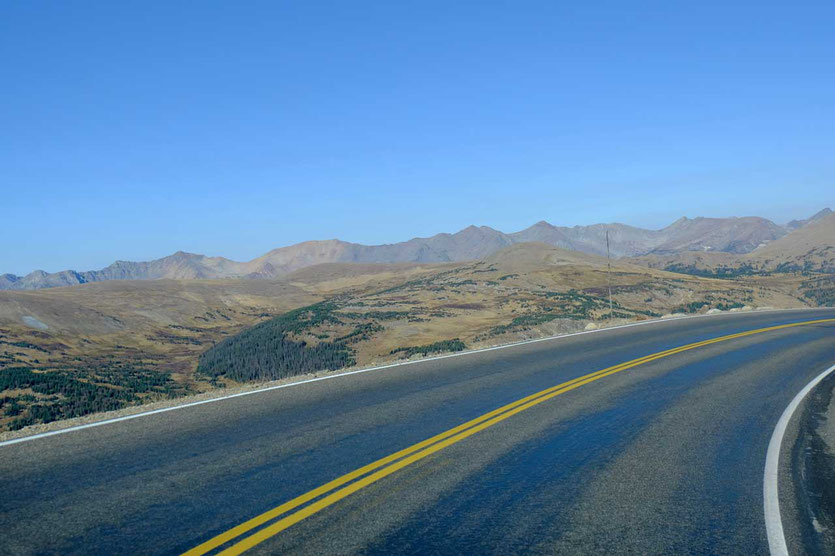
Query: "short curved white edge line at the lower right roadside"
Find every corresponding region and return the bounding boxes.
[763,358,835,556]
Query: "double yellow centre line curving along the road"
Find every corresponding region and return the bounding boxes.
[183,319,835,556]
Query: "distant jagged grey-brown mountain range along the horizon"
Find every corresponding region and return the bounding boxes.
[0,208,833,290]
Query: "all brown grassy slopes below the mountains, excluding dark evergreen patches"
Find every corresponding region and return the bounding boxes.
[0,244,807,428]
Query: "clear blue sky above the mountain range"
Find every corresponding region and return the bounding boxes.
[0,0,835,274]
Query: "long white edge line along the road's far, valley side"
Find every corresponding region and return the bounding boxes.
[0,307,828,447]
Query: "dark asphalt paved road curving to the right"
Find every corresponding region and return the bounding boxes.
[0,310,835,554]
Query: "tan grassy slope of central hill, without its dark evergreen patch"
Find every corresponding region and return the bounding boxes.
[253,243,805,374]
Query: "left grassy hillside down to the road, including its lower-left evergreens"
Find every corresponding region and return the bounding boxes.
[0,265,442,430]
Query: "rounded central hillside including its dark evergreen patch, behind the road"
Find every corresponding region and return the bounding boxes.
[191,244,805,381]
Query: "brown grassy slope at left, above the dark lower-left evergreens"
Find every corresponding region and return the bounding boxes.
[0,265,450,382]
